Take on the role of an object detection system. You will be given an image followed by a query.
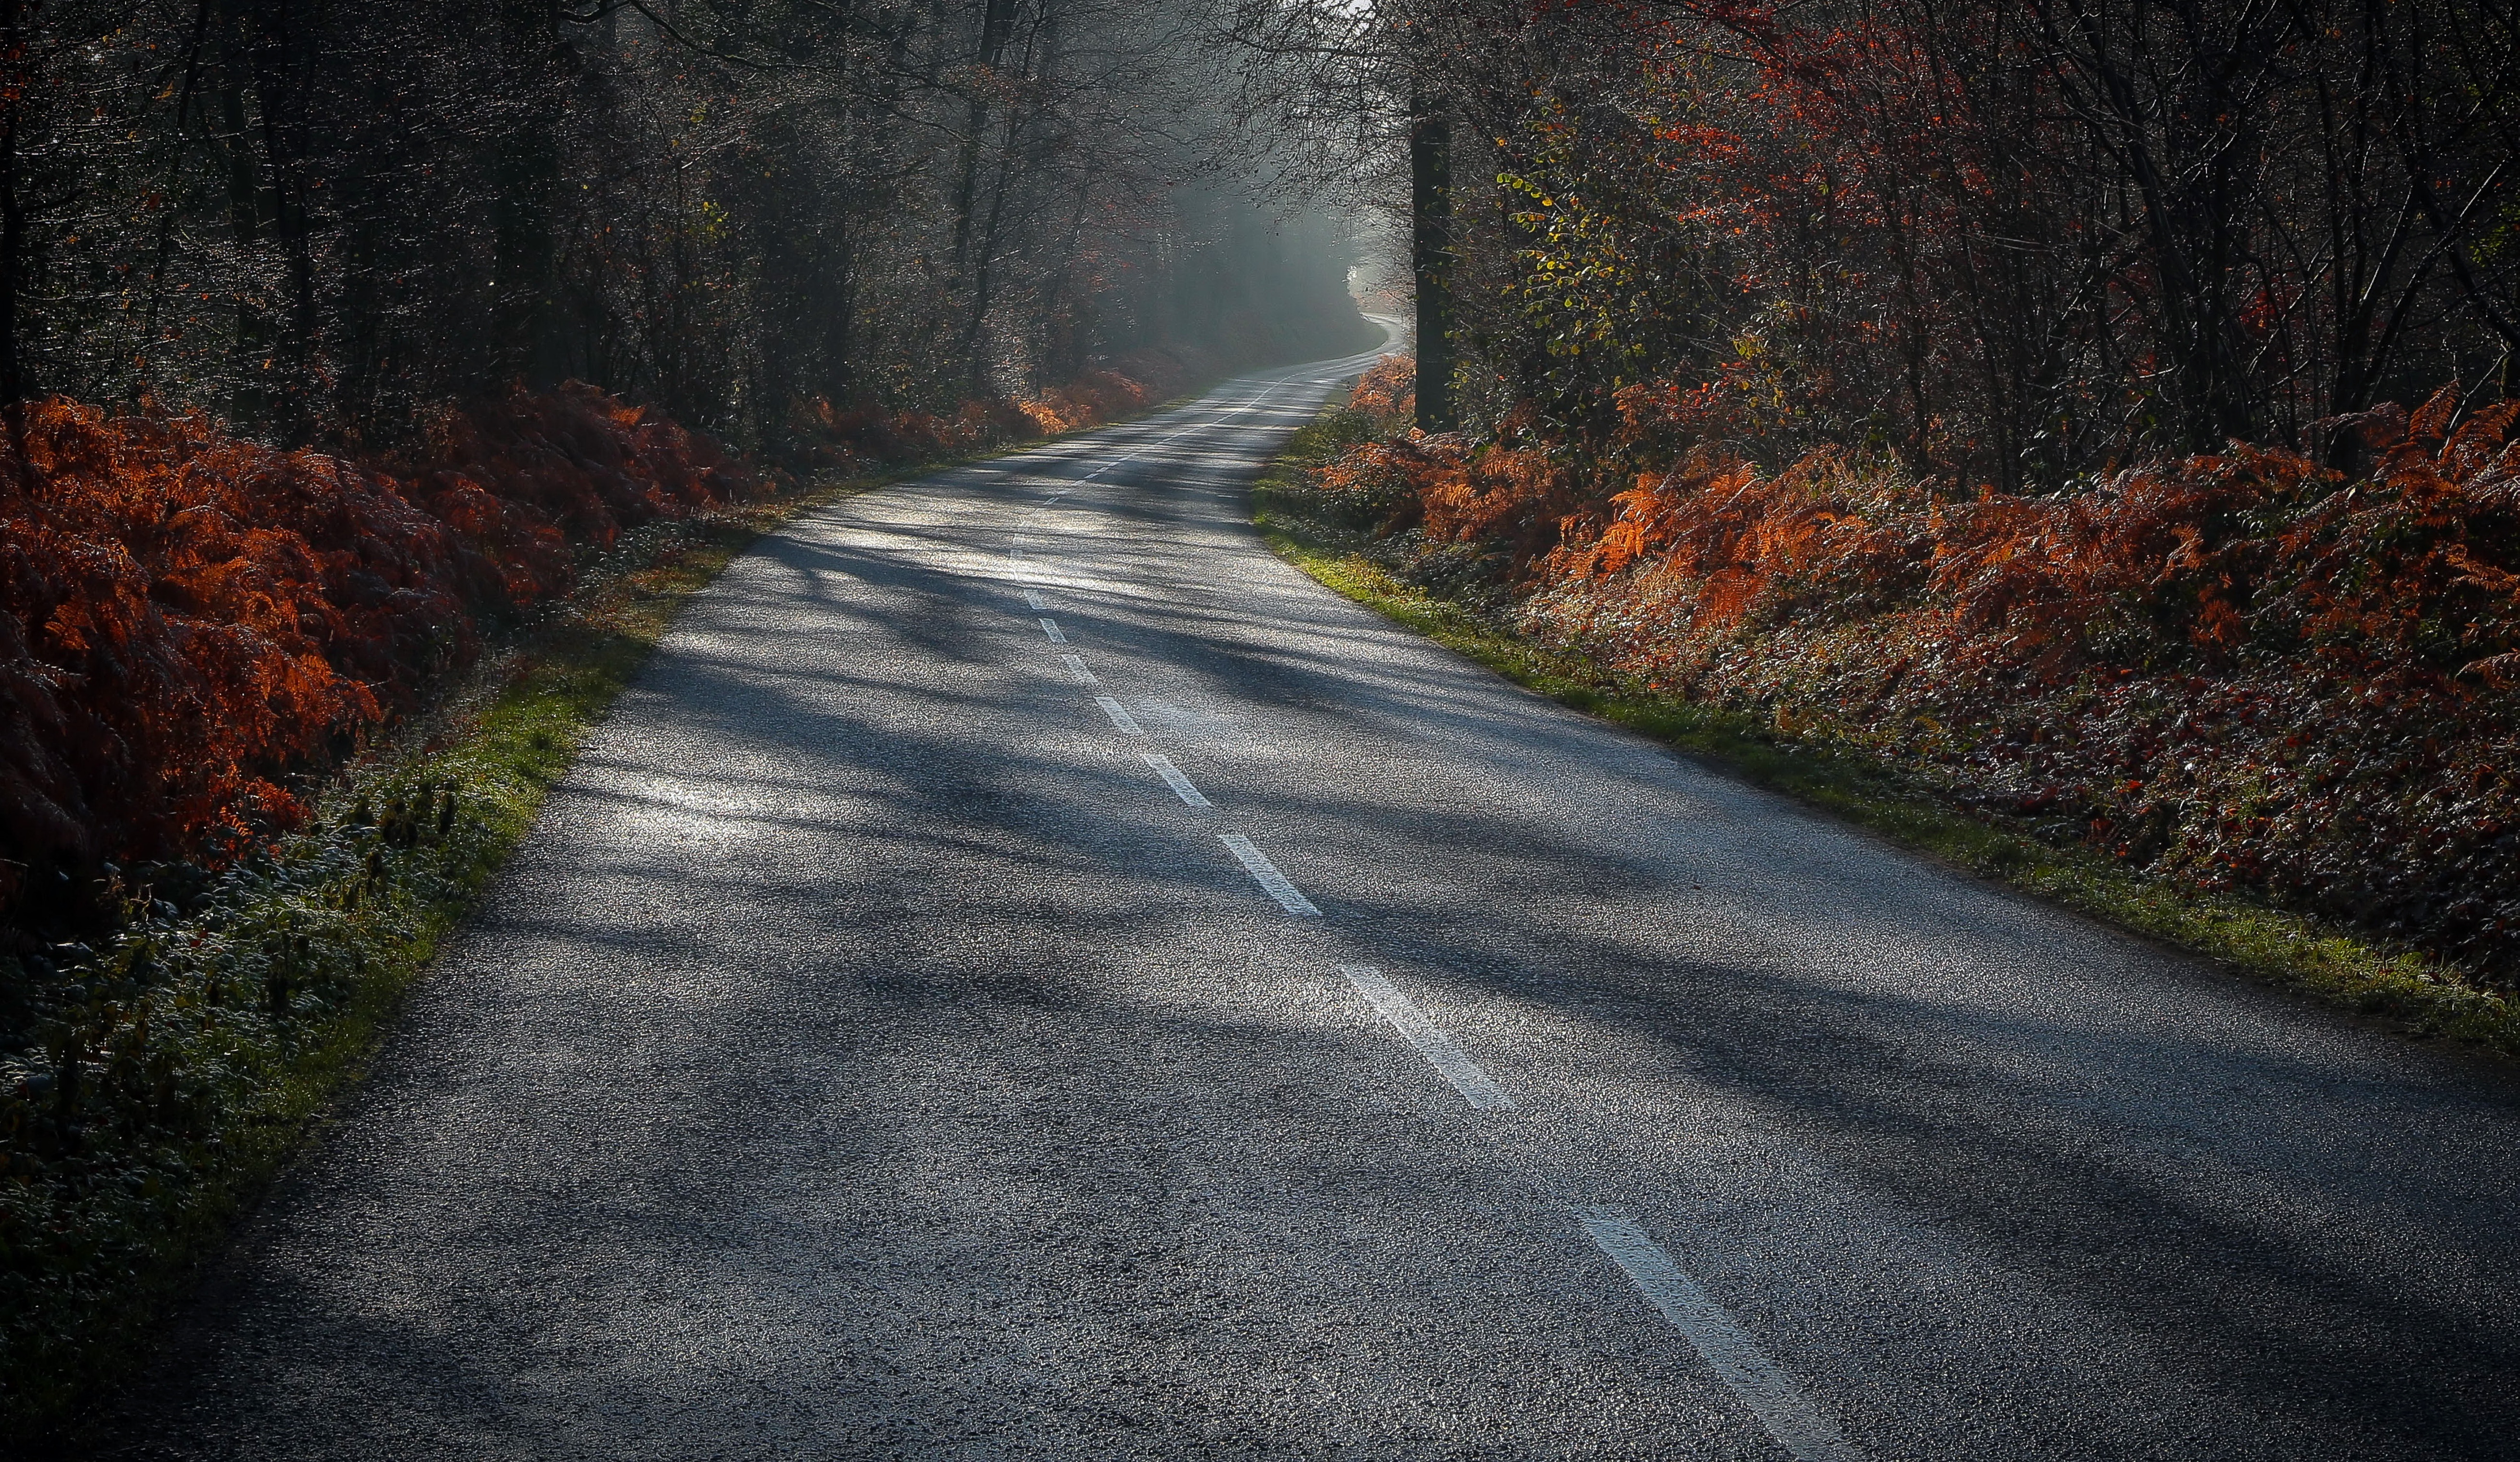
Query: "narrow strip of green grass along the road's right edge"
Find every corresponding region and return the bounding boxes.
[1253,416,2520,1056]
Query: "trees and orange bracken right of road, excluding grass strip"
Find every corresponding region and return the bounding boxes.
[1240,0,2520,991]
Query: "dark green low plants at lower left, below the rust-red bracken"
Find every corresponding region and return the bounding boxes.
[0,774,496,1427]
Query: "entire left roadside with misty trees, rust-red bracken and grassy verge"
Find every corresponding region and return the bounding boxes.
[0,0,1378,1452]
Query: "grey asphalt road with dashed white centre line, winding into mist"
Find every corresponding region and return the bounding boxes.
[108,337,2520,1460]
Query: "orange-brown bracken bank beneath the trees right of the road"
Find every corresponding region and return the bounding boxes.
[1318,365,2520,980]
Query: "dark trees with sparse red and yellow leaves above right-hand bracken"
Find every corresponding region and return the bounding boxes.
[1235,0,2520,489]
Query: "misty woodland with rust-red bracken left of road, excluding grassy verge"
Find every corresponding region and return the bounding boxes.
[0,0,1371,938]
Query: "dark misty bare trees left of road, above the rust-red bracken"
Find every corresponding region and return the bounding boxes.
[0,0,1361,446]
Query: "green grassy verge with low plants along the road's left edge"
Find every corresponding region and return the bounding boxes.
[0,396,1187,1457]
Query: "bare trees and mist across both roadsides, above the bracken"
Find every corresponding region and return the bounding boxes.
[0,0,2520,486]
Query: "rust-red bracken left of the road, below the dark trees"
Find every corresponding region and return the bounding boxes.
[0,386,759,932]
